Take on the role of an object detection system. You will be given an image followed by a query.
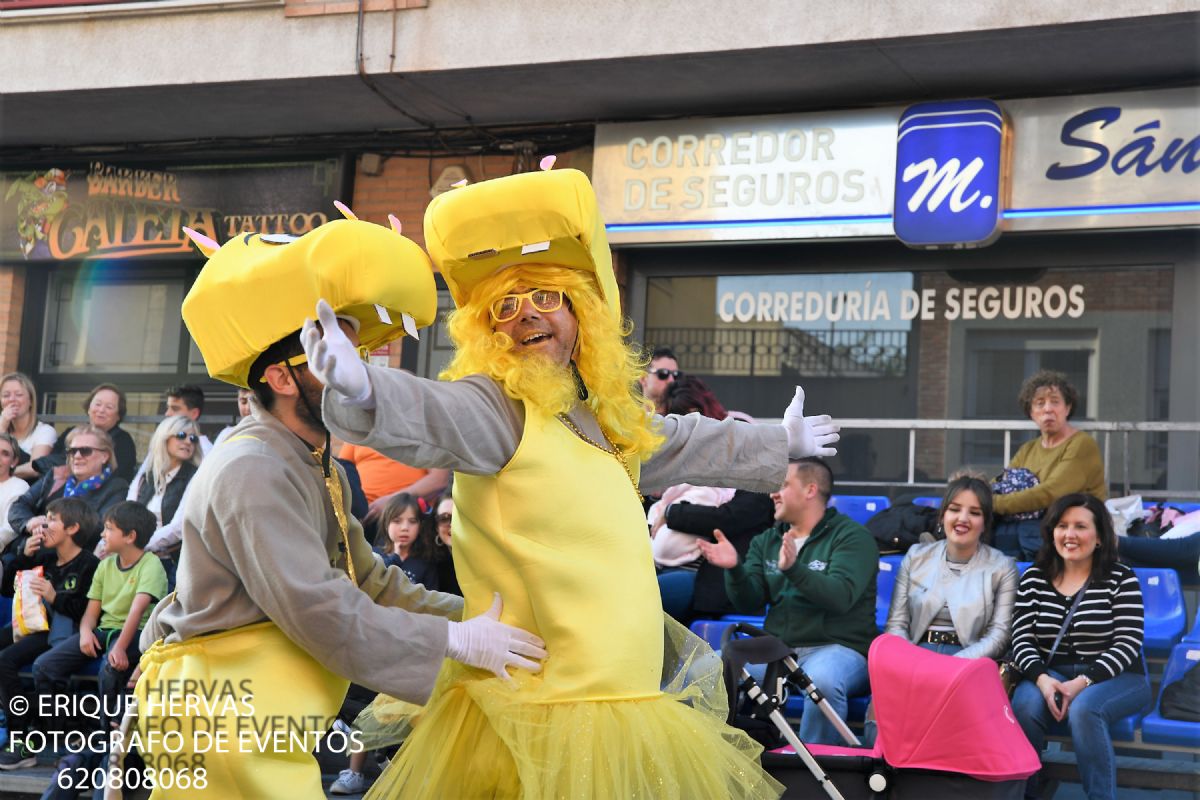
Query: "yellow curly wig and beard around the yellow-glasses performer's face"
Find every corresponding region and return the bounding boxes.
[440,264,664,461]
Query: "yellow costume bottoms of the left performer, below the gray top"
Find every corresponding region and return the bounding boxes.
[134,622,349,800]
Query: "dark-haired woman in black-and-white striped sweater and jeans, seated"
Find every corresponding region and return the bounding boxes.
[1013,494,1151,800]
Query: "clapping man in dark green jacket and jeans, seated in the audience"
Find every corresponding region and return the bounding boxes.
[700,458,880,745]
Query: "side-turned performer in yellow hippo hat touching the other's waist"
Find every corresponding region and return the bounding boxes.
[136,219,545,800]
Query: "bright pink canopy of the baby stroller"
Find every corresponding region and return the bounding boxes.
[868,634,1042,781]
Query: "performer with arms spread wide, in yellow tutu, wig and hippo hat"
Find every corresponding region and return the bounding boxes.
[301,165,838,800]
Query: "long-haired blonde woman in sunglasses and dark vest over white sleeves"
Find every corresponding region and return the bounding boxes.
[126,414,204,575]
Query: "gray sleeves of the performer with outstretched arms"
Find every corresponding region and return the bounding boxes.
[323,367,787,493]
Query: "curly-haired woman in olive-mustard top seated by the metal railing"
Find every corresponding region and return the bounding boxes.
[995,369,1108,560]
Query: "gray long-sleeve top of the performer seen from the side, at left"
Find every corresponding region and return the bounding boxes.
[142,404,462,703]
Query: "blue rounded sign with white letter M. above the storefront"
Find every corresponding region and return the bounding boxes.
[894,100,1007,247]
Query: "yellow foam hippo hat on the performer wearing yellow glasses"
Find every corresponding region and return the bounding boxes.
[425,169,620,318]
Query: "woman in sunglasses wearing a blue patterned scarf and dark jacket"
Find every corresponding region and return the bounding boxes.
[5,425,130,553]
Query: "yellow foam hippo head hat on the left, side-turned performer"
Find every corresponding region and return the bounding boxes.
[184,219,438,387]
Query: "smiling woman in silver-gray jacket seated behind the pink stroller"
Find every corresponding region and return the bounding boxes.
[884,475,1018,658]
